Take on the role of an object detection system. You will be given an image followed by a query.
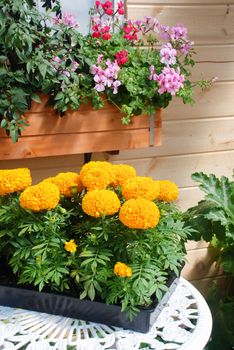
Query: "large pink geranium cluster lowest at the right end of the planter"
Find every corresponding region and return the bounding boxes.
[149,66,184,95]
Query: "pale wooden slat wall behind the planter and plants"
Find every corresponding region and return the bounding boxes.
[0,0,234,291]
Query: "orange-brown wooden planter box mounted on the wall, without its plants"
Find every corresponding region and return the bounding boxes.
[0,96,162,160]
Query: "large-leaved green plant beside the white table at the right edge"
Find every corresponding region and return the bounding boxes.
[185,173,234,350]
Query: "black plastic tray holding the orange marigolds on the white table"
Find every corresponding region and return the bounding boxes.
[0,275,178,333]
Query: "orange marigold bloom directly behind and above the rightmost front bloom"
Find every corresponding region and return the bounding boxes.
[122,176,159,200]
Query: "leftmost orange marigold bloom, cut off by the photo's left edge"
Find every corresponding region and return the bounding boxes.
[0,168,32,196]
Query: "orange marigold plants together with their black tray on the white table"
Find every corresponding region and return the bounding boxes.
[0,162,190,332]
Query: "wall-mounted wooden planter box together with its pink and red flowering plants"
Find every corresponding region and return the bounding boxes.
[0,0,204,159]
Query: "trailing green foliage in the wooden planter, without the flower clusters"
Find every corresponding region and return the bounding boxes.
[0,0,206,142]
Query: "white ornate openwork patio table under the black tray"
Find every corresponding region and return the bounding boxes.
[0,278,212,350]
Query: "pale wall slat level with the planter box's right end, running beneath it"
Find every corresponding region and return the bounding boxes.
[104,117,234,161]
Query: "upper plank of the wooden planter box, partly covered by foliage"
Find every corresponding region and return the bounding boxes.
[0,104,162,138]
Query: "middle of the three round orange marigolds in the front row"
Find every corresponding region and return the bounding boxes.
[82,190,120,218]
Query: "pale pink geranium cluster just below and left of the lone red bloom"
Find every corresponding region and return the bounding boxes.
[91,59,121,94]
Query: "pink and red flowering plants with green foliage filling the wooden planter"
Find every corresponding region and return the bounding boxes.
[0,0,212,142]
